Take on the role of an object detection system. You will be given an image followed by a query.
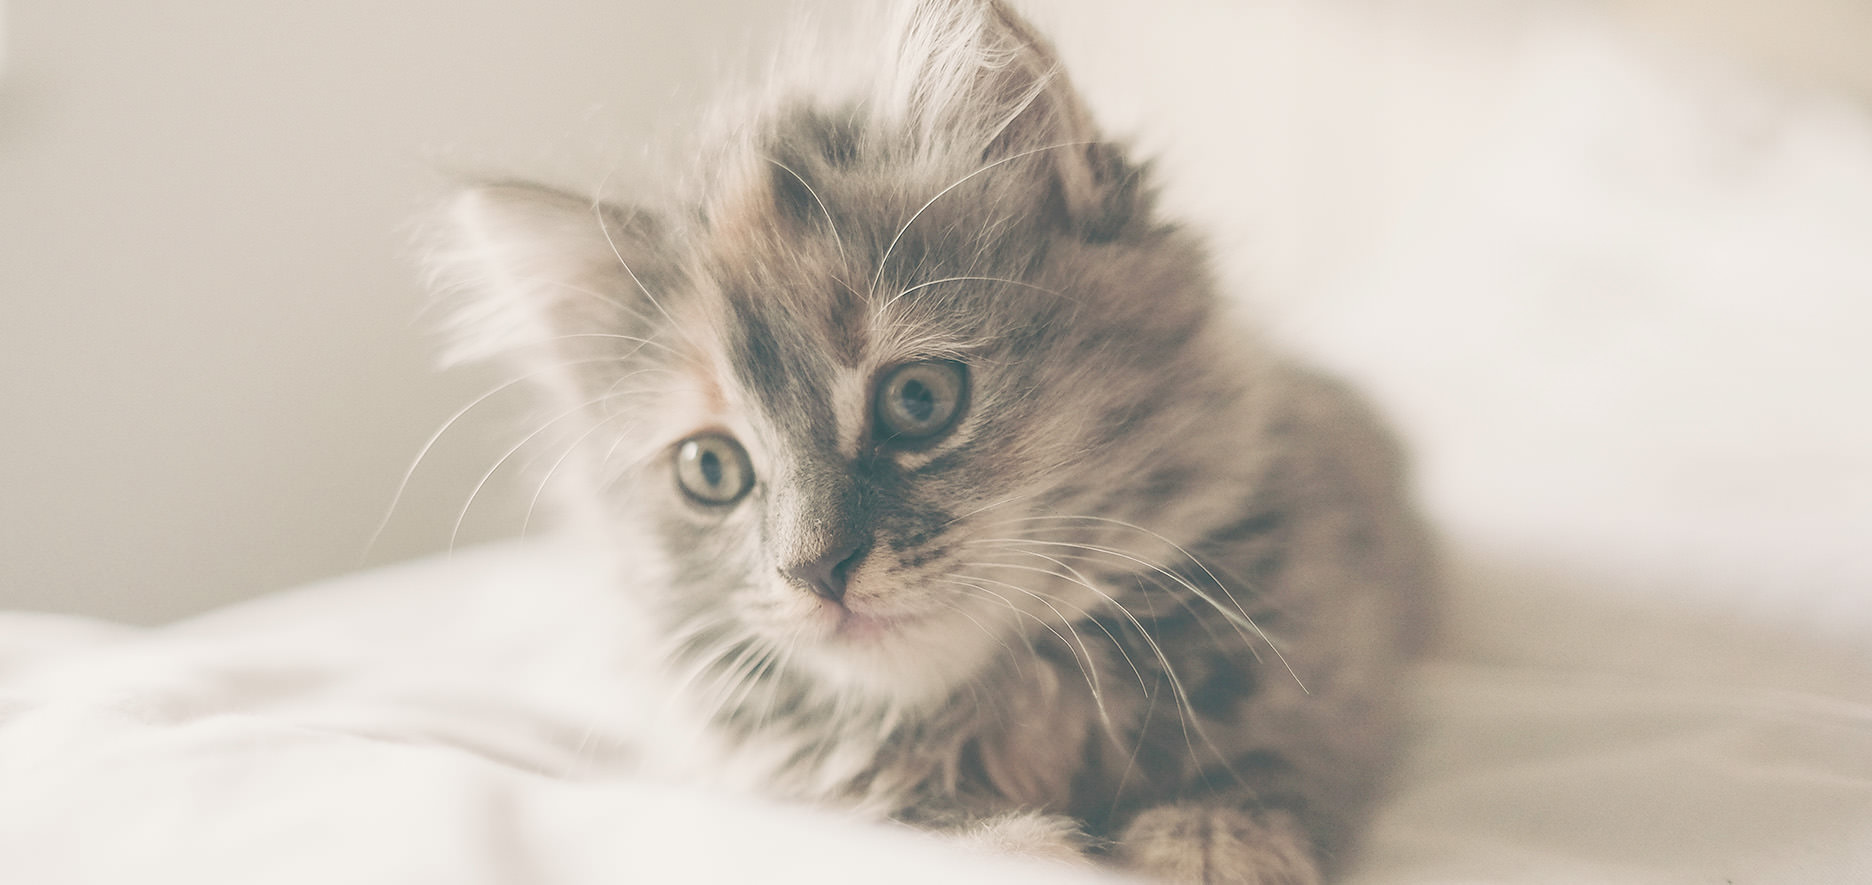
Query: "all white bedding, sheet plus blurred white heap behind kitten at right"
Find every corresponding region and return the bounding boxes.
[0,3,1872,885]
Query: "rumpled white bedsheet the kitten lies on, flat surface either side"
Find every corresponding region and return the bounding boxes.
[0,541,1872,885]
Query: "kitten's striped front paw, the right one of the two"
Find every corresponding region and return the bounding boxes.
[1118,805,1320,885]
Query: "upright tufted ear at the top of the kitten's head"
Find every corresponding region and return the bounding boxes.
[893,0,1142,241]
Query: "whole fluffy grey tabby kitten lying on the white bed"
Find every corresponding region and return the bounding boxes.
[440,0,1432,883]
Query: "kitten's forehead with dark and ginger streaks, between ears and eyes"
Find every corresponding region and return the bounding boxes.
[681,110,1060,457]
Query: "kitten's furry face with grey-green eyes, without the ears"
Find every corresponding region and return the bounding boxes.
[614,136,1217,698]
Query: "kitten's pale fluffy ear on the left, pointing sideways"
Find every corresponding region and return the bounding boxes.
[429,181,668,367]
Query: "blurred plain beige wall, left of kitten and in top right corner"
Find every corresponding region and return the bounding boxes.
[0,0,1872,621]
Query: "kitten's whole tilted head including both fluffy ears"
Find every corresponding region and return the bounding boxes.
[444,0,1256,702]
